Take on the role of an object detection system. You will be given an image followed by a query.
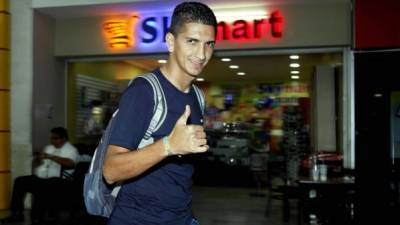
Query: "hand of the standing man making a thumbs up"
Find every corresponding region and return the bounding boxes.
[169,105,209,155]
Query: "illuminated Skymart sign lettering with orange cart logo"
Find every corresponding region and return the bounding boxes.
[103,11,283,50]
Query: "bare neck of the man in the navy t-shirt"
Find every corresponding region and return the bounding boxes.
[160,63,194,93]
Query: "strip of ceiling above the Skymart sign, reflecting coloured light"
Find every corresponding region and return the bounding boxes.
[33,0,351,19]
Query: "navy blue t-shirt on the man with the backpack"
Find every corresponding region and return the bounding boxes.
[108,69,202,225]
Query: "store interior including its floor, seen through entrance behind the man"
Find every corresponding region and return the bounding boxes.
[43,50,350,224]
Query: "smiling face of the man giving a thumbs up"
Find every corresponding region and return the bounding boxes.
[169,23,215,77]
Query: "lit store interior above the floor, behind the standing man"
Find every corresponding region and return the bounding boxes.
[67,52,342,186]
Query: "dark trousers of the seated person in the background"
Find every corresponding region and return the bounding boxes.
[11,175,64,220]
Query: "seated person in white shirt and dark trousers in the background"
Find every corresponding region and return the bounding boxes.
[3,127,79,222]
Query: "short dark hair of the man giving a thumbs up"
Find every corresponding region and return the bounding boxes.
[169,2,217,36]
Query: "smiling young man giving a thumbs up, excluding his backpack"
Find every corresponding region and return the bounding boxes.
[103,2,217,225]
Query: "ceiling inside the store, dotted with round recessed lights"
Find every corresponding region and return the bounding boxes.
[124,53,342,82]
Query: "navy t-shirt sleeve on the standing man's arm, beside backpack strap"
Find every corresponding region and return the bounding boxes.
[109,78,154,150]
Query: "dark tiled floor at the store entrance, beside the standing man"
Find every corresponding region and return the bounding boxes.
[0,187,297,225]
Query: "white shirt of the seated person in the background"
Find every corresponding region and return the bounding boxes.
[34,142,79,178]
